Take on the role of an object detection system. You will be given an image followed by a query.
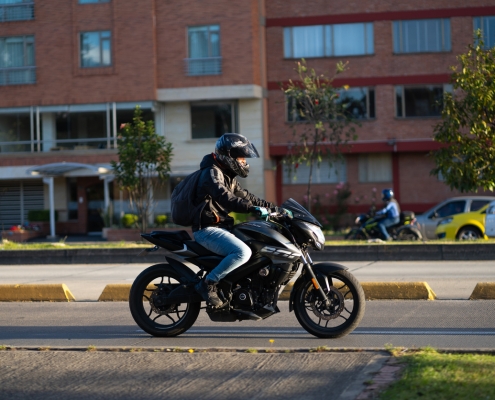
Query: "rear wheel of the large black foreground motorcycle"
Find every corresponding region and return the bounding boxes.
[129,264,201,337]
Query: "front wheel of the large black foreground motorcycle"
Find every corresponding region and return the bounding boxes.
[294,270,365,339]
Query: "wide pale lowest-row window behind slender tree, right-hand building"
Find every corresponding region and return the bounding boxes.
[282,158,347,185]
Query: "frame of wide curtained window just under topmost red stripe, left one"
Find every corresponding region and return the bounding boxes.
[282,22,375,60]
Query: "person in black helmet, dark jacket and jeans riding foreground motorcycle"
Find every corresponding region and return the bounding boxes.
[192,133,275,307]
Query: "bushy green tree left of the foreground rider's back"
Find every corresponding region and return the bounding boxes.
[111,106,173,232]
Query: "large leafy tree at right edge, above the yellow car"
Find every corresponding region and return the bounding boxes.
[431,31,495,192]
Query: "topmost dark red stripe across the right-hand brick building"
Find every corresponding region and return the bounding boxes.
[266,6,495,28]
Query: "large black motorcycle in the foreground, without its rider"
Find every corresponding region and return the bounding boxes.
[129,199,365,338]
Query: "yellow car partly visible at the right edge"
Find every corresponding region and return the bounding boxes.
[435,204,488,240]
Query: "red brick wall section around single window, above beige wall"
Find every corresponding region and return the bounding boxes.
[156,0,261,88]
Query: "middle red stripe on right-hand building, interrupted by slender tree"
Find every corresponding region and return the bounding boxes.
[268,74,451,90]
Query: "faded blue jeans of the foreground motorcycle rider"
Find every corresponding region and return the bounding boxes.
[194,226,252,283]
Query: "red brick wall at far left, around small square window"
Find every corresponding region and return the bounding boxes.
[0,0,156,107]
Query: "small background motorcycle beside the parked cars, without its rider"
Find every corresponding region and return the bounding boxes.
[345,207,423,240]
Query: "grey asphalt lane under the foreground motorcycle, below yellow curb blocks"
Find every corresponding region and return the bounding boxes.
[0,300,495,349]
